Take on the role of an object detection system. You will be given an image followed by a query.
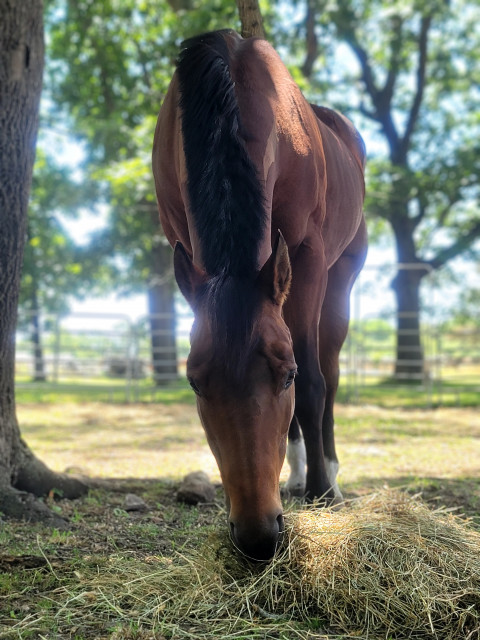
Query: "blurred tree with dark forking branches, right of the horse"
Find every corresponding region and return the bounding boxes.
[296,0,480,377]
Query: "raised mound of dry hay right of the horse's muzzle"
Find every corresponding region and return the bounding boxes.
[255,491,480,639]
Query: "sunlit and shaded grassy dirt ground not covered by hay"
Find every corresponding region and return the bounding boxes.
[0,403,480,640]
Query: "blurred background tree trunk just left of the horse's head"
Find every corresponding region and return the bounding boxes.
[148,207,178,386]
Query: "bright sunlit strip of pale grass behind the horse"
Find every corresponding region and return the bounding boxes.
[18,402,480,510]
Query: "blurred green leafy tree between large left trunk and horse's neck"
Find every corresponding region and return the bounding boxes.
[47,0,238,381]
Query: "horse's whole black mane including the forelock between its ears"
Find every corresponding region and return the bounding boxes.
[177,32,266,382]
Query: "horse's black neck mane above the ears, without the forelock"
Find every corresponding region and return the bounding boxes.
[177,32,265,278]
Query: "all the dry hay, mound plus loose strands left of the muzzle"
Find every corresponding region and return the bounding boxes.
[38,491,480,640]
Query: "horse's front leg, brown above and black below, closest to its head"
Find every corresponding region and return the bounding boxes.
[284,246,335,501]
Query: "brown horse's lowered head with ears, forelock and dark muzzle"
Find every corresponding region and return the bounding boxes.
[174,235,297,560]
